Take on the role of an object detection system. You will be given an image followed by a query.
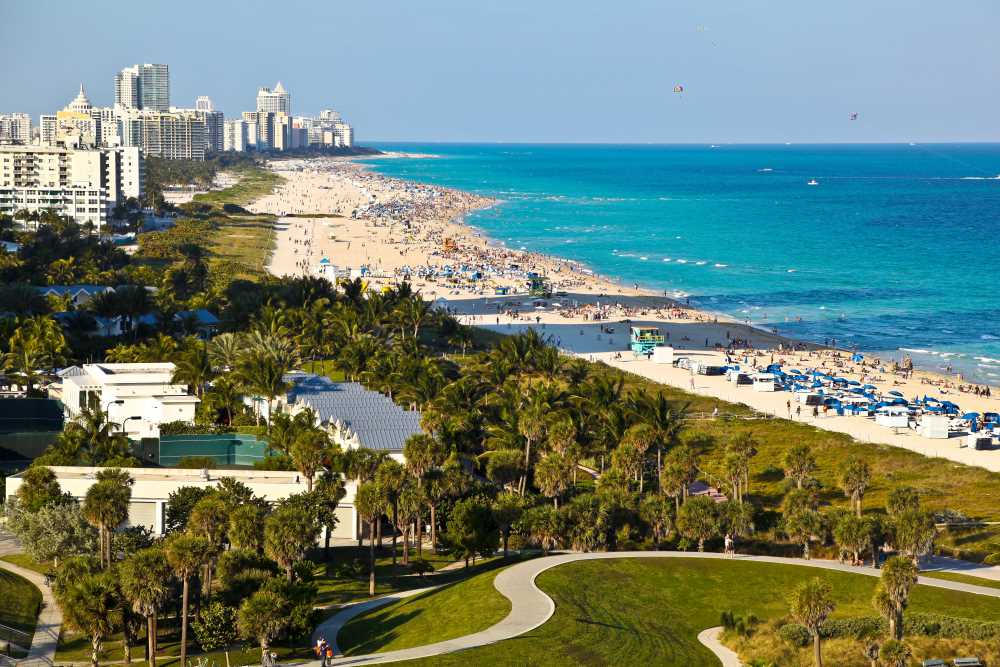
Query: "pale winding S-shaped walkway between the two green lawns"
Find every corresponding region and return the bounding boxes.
[311,551,1000,665]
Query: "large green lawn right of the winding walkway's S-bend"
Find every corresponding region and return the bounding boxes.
[397,559,1000,667]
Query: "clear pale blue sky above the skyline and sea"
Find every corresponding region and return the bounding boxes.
[0,0,1000,144]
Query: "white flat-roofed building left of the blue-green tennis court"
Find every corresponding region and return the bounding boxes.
[53,362,200,439]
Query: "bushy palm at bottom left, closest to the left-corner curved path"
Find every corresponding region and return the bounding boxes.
[59,572,122,667]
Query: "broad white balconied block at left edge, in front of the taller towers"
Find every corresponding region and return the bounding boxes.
[0,146,144,232]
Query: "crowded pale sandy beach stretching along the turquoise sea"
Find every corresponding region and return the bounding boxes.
[251,158,1000,471]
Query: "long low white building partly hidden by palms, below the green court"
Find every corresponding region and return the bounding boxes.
[7,466,358,542]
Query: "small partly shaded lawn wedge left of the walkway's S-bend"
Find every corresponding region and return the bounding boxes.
[337,569,510,655]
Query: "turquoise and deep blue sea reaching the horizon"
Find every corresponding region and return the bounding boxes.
[366,144,1000,384]
